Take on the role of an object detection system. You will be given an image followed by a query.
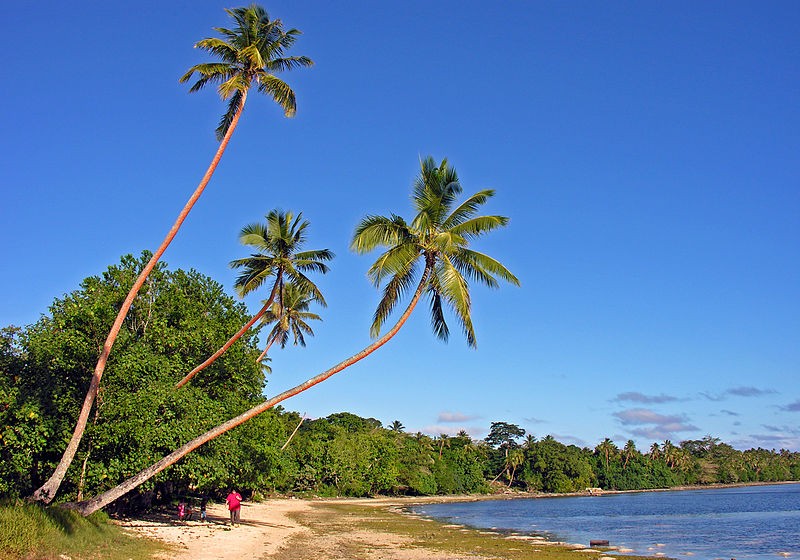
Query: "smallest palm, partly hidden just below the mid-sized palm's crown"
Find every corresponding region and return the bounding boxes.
[256,284,322,362]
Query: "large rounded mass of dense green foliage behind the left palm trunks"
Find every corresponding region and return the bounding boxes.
[0,254,264,506]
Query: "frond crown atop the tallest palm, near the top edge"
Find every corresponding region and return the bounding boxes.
[180,4,314,140]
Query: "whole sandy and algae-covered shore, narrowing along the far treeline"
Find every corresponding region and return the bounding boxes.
[116,481,800,560]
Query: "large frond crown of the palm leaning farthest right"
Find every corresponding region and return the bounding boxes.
[351,157,519,346]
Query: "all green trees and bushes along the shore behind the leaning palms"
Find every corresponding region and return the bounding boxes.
[0,255,800,507]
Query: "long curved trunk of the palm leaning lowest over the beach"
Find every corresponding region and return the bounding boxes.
[66,267,431,516]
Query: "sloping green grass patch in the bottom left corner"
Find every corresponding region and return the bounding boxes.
[0,501,164,560]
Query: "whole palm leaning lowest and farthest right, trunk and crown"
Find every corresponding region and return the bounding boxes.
[73,158,520,515]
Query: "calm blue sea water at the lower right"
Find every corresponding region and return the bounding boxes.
[413,484,800,560]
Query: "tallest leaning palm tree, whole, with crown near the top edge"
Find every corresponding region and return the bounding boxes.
[32,4,313,503]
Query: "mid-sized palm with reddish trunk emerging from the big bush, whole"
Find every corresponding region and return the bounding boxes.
[175,210,333,389]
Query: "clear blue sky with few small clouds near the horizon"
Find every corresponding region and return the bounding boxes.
[0,0,800,450]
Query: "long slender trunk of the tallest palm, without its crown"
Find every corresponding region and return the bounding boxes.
[31,91,247,504]
